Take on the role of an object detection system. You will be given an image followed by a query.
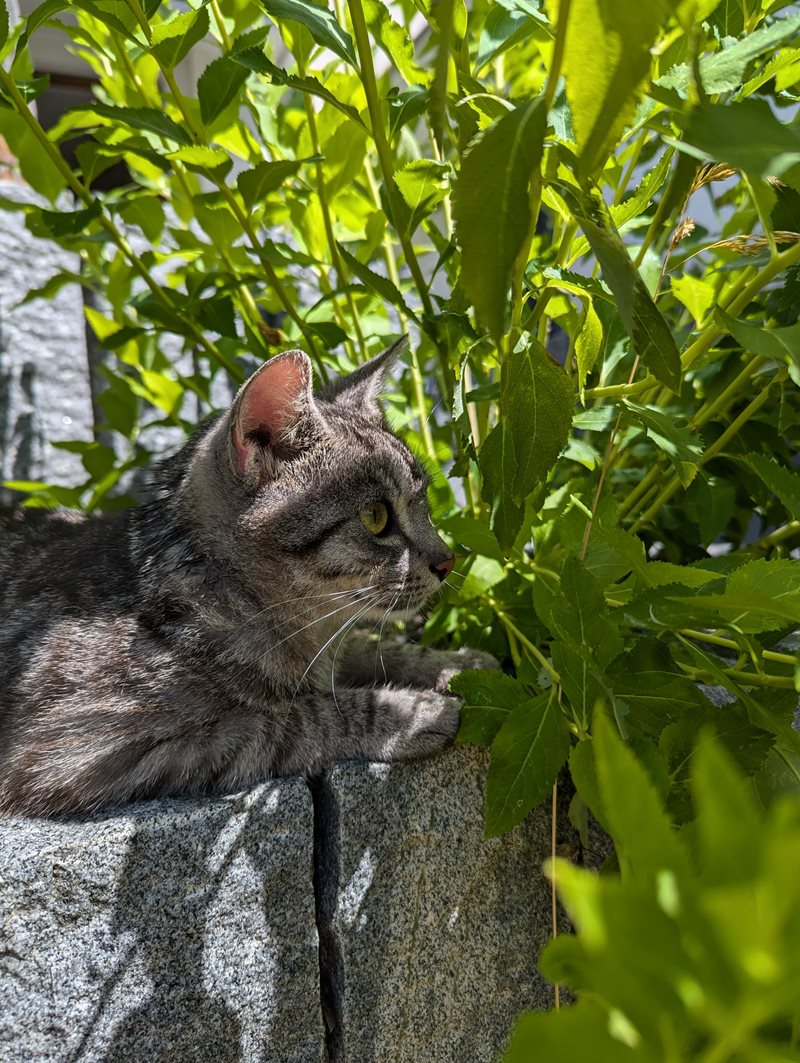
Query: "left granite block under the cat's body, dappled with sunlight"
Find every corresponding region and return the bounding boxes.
[0,779,324,1063]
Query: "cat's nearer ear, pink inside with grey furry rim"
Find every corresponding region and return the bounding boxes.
[228,351,320,483]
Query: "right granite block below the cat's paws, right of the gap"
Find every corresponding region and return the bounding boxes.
[316,747,554,1063]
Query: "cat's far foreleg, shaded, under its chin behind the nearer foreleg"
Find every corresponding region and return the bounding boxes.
[339,634,499,693]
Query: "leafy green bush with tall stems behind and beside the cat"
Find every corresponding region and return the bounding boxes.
[0,0,800,1060]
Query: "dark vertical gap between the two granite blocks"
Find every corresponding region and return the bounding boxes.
[308,774,345,1063]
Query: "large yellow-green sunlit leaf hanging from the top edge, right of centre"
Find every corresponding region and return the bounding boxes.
[562,0,678,178]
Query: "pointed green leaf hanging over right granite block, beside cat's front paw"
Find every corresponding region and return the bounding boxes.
[483,689,569,838]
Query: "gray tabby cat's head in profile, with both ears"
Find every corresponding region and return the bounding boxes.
[183,341,453,619]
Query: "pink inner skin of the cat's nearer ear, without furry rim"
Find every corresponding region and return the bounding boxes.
[231,351,310,474]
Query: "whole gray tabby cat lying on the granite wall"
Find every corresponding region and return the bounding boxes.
[0,344,494,815]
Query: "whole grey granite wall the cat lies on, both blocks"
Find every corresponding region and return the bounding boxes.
[0,747,566,1063]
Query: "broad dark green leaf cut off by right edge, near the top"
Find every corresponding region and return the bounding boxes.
[677,99,800,187]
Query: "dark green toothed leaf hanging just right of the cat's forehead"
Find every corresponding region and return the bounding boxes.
[478,340,575,550]
